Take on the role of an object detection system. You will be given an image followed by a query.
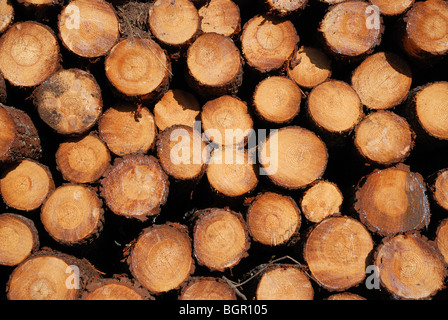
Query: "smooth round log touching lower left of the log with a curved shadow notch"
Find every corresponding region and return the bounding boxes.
[306,80,364,135]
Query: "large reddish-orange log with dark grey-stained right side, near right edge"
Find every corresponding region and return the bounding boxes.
[355,164,430,236]
